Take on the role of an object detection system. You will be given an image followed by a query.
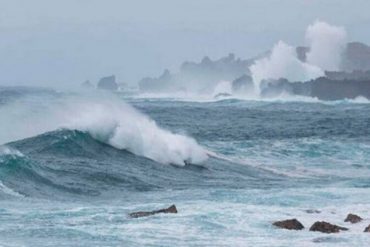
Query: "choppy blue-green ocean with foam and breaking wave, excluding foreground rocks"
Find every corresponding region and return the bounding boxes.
[0,87,370,247]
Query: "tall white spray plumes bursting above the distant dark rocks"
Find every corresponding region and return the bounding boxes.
[249,21,346,96]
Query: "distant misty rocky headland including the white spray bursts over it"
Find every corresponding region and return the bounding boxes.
[138,21,370,100]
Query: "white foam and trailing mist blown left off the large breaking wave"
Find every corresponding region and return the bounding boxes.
[0,94,208,166]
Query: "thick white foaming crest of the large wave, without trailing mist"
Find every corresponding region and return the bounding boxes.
[66,98,207,165]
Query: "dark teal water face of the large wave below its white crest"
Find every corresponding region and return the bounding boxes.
[0,130,286,200]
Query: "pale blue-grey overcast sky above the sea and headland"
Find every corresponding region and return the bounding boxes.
[0,0,370,86]
